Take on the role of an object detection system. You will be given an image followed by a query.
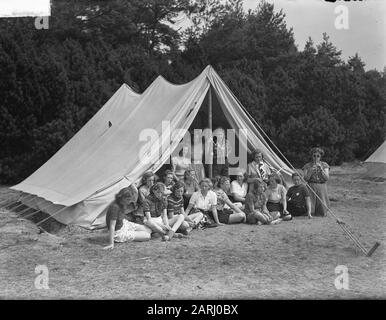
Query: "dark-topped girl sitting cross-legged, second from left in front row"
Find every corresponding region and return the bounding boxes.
[143,182,184,241]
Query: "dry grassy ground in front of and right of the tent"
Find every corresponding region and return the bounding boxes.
[0,164,386,299]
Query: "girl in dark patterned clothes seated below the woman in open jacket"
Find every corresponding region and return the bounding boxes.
[245,180,281,224]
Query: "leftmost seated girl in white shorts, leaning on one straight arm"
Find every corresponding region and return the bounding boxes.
[104,187,151,249]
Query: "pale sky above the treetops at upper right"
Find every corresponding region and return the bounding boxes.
[244,0,386,71]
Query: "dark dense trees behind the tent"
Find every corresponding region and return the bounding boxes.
[0,0,386,183]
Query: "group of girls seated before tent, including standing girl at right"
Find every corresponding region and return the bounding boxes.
[105,148,328,249]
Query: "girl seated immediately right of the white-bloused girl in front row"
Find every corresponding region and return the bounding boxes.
[213,176,246,224]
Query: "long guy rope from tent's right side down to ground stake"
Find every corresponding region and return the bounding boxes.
[232,94,380,257]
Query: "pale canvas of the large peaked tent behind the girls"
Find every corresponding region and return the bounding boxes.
[12,66,292,229]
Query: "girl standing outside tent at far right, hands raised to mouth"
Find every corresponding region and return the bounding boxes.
[303,148,330,217]
